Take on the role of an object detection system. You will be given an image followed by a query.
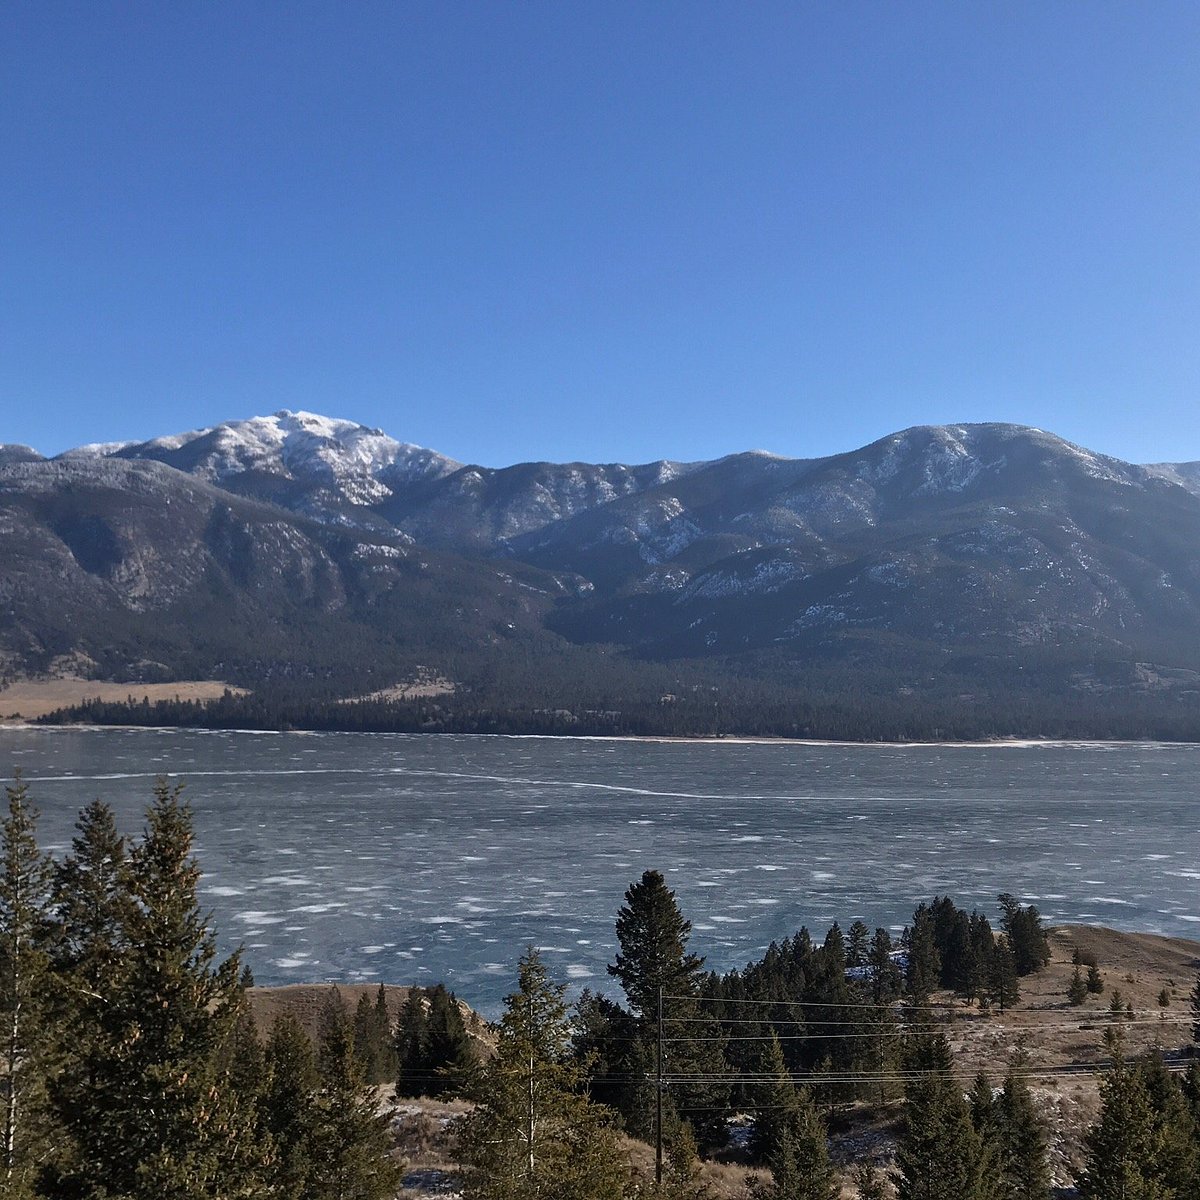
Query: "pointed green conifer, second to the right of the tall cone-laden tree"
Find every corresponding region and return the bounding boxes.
[307,997,401,1200]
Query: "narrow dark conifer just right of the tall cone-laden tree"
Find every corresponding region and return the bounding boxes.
[259,1014,320,1200]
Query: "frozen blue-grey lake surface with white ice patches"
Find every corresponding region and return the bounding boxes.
[0,727,1200,1012]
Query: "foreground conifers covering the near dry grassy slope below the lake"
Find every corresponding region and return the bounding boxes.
[0,776,1200,1200]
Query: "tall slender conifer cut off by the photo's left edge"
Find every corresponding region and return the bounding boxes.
[0,775,54,1200]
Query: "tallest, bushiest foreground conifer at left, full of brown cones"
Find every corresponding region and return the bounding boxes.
[53,780,263,1200]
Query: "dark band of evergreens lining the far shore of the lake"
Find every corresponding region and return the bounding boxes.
[38,676,1200,742]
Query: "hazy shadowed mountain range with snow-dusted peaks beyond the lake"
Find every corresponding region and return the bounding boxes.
[0,413,1200,720]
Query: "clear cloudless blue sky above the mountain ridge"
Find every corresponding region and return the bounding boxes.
[0,0,1200,464]
